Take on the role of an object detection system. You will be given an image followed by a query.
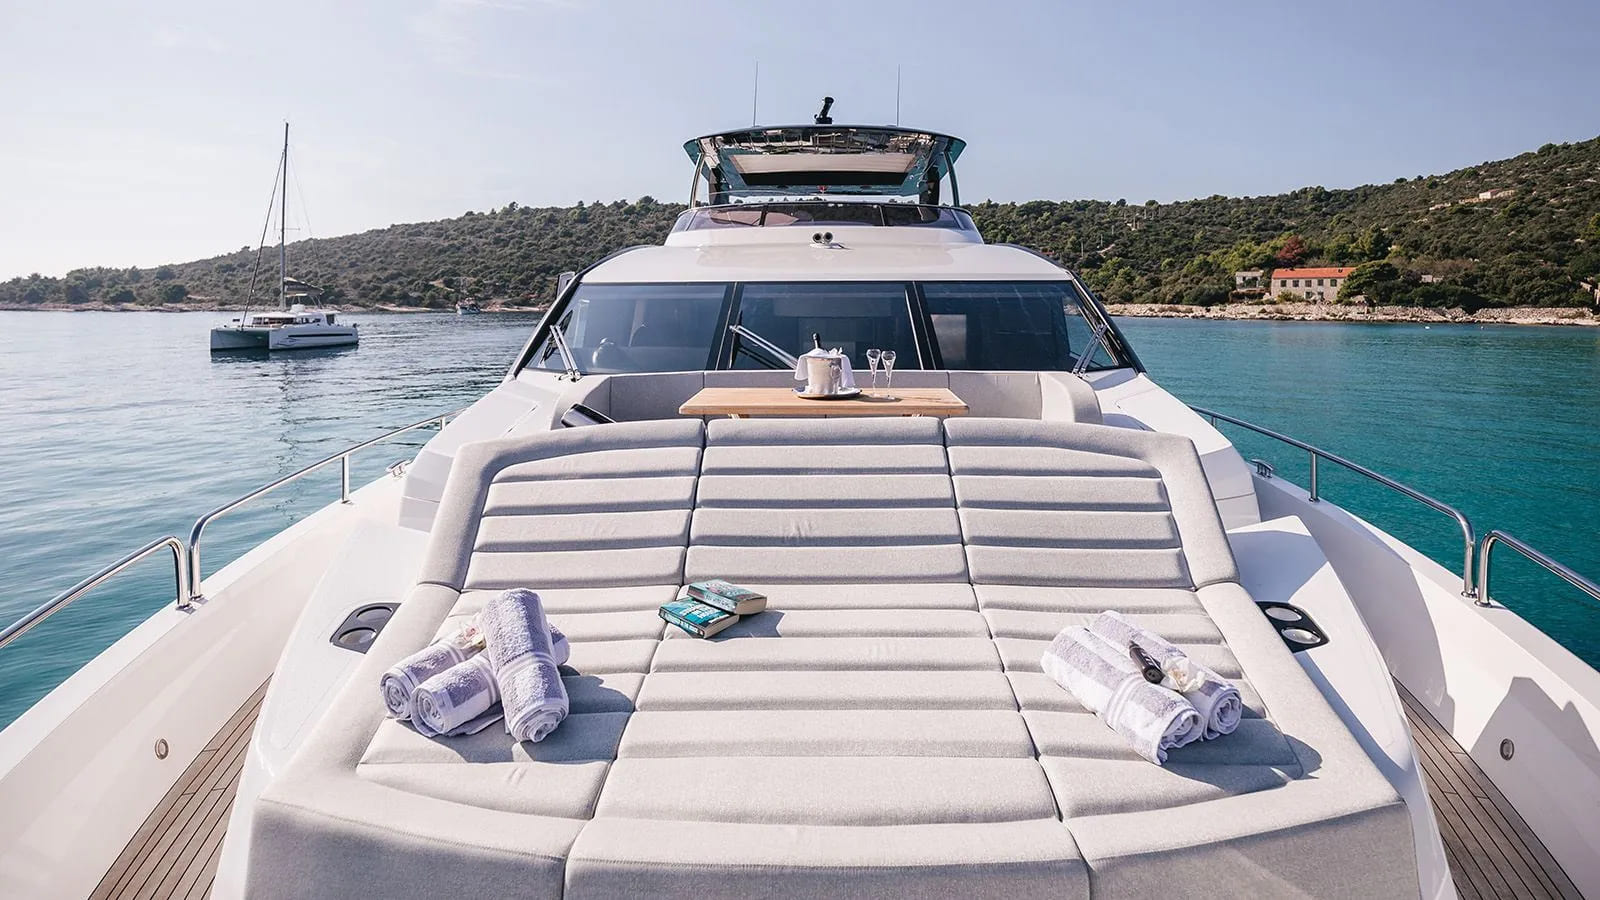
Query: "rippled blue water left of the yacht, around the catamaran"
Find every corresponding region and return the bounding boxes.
[0,312,538,724]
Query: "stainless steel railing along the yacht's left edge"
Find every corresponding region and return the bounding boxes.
[0,410,461,647]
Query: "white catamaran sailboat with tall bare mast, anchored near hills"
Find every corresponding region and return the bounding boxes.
[211,122,362,352]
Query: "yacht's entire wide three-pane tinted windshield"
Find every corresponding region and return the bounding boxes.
[530,280,1133,375]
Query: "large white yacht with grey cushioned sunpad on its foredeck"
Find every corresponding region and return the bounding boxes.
[0,112,1600,898]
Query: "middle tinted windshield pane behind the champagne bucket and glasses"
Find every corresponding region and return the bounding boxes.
[733,283,922,372]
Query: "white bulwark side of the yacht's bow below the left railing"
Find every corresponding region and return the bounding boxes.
[0,477,400,898]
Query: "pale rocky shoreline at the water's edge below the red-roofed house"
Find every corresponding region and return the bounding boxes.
[1106,303,1600,325]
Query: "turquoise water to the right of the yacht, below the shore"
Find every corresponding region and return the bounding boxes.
[1118,319,1600,666]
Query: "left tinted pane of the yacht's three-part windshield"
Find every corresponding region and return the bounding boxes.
[533,283,728,373]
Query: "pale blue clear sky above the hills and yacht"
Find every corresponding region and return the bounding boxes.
[0,0,1600,279]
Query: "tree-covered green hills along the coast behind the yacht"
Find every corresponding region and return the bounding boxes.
[9,138,1600,311]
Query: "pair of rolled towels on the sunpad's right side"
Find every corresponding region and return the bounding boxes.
[1040,610,1243,764]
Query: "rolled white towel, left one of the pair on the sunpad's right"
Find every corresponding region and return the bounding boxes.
[1040,626,1200,765]
